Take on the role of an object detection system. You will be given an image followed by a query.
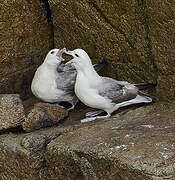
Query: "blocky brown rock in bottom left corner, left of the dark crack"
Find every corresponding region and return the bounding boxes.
[0,129,60,180]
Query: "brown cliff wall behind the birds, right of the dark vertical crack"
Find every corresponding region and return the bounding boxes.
[49,0,175,100]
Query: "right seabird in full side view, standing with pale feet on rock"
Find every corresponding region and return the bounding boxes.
[66,49,152,122]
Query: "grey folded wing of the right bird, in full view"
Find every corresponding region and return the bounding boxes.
[98,77,137,104]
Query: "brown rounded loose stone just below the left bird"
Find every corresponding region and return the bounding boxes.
[22,103,68,132]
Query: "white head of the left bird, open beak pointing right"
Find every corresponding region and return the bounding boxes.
[44,48,66,66]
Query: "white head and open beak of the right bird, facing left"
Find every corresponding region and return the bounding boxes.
[65,49,92,70]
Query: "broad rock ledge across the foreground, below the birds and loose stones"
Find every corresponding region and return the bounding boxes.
[0,103,175,180]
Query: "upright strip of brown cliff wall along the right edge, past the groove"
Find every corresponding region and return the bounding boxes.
[145,0,175,100]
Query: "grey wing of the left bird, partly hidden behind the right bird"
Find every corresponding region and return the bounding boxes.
[56,71,77,92]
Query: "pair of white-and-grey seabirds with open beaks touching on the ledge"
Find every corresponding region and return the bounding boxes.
[31,49,152,122]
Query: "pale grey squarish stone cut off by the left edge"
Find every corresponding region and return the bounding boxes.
[0,94,25,130]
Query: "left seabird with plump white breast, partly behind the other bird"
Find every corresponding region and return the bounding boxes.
[31,49,104,110]
